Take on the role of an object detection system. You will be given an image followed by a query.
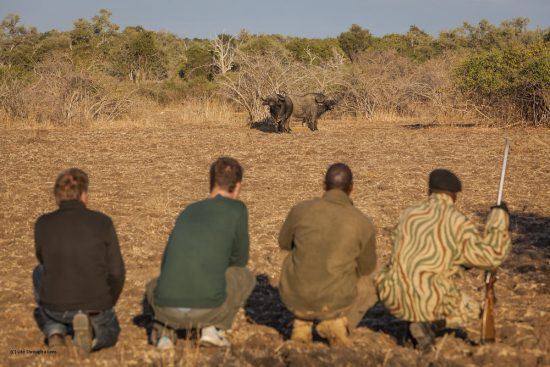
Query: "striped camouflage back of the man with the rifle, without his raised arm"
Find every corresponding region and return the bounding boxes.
[379,194,466,321]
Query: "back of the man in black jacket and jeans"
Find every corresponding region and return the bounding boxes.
[35,200,124,311]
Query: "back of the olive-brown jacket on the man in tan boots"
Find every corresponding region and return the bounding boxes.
[280,189,376,313]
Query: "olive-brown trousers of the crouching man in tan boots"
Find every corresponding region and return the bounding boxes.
[286,276,378,331]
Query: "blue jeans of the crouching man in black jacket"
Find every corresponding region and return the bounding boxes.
[32,265,120,350]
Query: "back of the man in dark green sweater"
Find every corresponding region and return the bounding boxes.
[155,195,248,308]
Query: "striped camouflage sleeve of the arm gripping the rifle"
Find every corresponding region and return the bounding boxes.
[457,208,512,269]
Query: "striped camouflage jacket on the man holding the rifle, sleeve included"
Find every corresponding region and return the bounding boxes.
[375,193,511,322]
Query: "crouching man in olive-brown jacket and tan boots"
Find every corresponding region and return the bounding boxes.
[279,163,377,346]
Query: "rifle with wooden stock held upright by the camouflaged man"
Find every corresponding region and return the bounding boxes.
[480,138,510,344]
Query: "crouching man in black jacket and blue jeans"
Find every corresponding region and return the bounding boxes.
[33,168,125,353]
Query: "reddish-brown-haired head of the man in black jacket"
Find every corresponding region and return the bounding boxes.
[53,168,90,205]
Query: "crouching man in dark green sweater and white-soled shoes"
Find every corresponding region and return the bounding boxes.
[146,157,255,349]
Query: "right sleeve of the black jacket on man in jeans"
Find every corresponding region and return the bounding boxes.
[106,220,126,306]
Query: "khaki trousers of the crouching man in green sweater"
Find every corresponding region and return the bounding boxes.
[146,267,256,330]
